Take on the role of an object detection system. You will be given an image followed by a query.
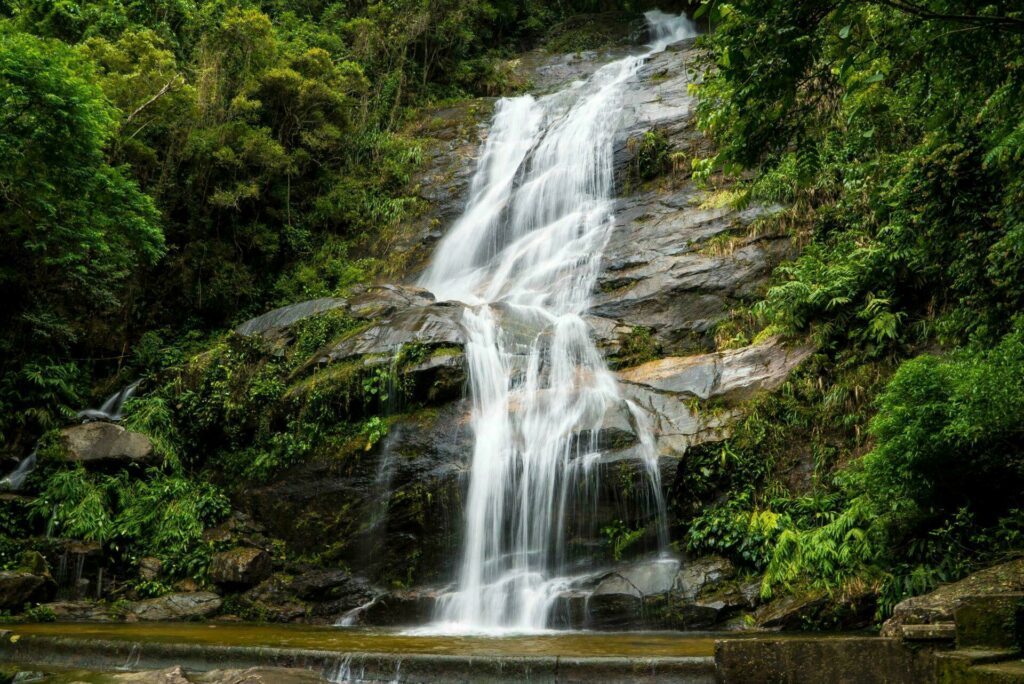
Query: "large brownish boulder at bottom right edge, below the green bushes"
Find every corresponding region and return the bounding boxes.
[882,558,1024,637]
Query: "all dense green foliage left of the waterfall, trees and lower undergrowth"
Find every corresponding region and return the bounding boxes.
[0,0,688,580]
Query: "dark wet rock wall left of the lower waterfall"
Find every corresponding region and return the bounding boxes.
[239,400,472,591]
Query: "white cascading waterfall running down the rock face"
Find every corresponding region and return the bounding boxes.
[421,11,696,632]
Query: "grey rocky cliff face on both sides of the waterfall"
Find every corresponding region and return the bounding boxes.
[228,37,810,627]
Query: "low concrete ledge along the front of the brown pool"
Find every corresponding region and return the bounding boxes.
[0,632,715,684]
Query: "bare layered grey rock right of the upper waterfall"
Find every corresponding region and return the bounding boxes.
[591,41,793,353]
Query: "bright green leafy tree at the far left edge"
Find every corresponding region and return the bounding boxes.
[0,31,164,446]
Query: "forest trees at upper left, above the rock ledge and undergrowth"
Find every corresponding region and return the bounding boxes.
[0,0,671,453]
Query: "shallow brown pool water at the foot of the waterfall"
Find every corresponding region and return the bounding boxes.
[11,623,720,657]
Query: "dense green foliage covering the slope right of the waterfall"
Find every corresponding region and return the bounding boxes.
[690,0,1024,607]
